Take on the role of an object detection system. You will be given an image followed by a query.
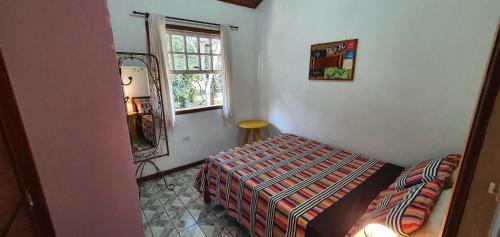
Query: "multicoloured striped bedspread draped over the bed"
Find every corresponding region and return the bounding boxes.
[195,134,399,237]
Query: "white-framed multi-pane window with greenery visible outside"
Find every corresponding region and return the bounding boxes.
[167,26,223,114]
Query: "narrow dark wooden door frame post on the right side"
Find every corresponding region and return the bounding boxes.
[442,24,500,237]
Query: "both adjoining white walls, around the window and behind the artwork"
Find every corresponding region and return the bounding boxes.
[108,0,500,172]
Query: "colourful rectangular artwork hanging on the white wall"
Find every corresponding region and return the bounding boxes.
[309,39,358,80]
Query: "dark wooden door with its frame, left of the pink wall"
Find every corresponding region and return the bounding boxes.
[0,51,55,237]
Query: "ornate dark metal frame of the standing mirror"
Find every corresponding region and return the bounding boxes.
[116,52,170,163]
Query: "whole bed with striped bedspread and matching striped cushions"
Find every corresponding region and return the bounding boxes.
[195,134,461,237]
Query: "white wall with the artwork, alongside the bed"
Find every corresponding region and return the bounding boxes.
[256,0,500,165]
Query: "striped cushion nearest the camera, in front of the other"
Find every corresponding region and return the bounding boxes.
[346,179,444,236]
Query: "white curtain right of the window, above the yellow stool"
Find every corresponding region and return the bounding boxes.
[220,25,232,119]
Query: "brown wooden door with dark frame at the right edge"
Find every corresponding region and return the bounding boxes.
[443,23,500,237]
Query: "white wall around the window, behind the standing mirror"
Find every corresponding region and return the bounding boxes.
[108,0,257,174]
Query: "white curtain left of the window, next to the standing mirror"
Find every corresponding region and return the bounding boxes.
[148,14,175,127]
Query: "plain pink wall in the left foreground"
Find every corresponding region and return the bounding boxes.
[0,0,143,237]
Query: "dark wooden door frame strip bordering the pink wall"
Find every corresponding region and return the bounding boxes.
[0,49,55,237]
